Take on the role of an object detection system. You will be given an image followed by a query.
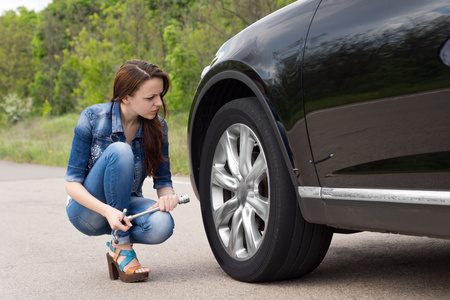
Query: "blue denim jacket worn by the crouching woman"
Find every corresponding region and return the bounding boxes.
[65,101,172,196]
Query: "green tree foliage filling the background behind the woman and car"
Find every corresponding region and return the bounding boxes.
[0,0,293,119]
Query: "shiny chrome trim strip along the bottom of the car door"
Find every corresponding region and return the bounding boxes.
[298,186,450,206]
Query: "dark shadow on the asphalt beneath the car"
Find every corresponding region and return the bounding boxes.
[271,233,450,298]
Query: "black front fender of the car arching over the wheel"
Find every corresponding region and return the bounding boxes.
[188,0,320,199]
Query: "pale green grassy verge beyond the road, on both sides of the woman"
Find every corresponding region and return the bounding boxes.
[0,113,189,174]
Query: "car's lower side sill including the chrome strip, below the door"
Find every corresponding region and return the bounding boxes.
[298,186,450,239]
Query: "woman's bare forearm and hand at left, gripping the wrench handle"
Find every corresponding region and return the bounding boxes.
[66,181,133,231]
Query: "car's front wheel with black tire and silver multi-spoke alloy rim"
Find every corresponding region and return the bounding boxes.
[199,98,333,282]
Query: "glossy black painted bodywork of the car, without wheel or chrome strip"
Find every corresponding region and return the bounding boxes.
[188,0,450,236]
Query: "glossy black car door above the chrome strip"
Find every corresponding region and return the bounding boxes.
[303,0,450,190]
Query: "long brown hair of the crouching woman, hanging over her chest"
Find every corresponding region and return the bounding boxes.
[111,59,169,176]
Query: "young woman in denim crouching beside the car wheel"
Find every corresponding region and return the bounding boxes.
[66,60,178,282]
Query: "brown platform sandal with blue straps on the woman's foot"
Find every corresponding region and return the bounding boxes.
[106,242,149,282]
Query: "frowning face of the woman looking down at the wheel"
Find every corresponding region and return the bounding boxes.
[124,77,164,119]
